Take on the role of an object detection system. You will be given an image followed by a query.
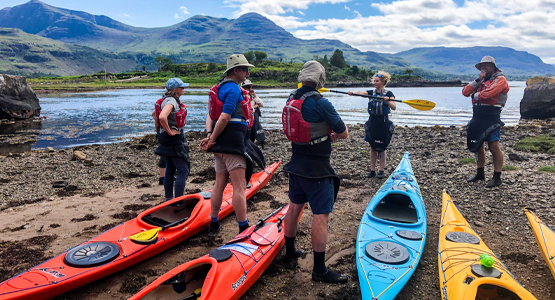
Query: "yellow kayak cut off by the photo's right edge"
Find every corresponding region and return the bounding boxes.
[524,208,555,278]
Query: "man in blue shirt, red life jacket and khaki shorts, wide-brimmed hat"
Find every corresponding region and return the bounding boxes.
[200,54,263,236]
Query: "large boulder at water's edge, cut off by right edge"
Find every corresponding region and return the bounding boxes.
[520,77,555,119]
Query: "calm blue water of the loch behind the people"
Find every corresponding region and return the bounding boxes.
[0,82,526,148]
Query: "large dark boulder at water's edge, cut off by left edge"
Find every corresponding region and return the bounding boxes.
[0,74,40,119]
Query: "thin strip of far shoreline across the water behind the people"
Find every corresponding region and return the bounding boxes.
[31,80,463,95]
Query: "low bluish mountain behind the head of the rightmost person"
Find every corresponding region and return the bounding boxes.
[391,47,555,76]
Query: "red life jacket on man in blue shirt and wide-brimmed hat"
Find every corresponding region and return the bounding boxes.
[208,79,254,129]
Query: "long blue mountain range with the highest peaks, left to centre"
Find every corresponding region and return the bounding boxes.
[0,0,410,68]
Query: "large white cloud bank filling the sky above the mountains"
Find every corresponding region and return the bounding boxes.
[225,0,555,63]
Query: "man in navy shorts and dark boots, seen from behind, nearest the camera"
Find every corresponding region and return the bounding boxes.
[282,61,349,283]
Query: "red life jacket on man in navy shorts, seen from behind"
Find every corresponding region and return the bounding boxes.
[281,91,332,145]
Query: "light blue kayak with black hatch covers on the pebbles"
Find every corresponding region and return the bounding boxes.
[356,152,427,300]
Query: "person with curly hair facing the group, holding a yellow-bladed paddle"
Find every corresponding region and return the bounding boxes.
[349,71,397,179]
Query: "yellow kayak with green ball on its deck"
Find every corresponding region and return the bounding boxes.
[438,190,536,300]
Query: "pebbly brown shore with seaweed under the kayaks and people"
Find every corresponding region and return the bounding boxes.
[0,120,555,300]
